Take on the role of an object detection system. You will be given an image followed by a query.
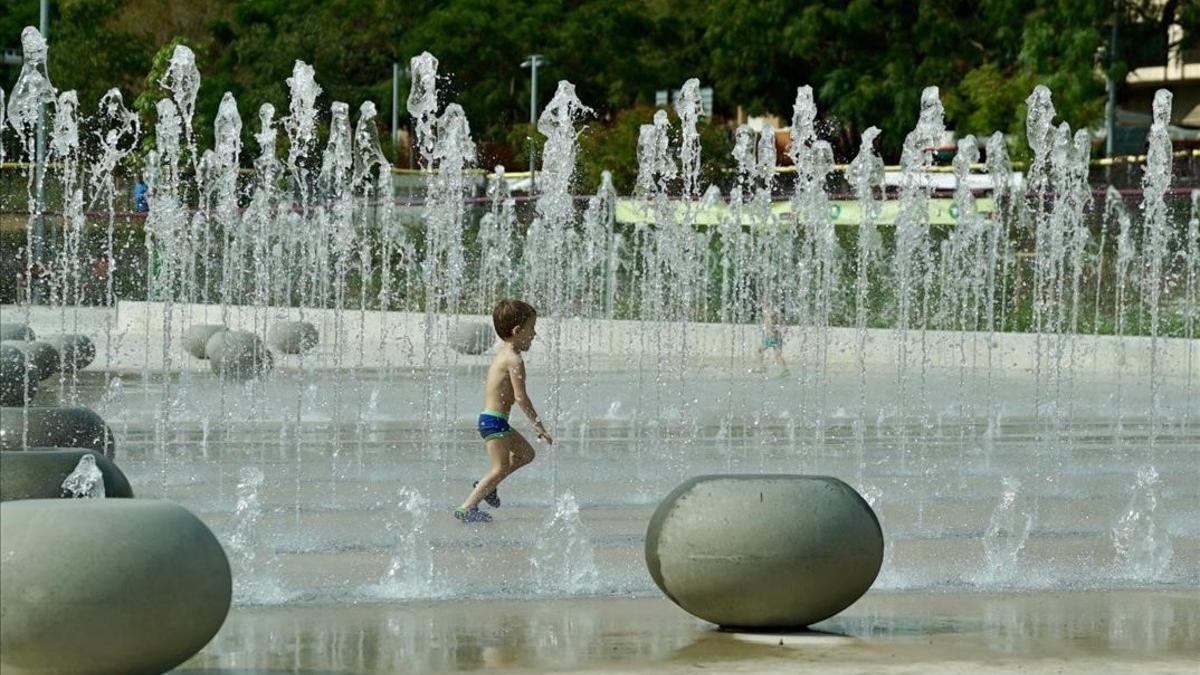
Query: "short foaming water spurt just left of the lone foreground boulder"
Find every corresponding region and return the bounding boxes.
[529,490,600,595]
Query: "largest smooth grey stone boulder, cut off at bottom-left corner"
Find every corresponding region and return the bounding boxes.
[0,500,233,675]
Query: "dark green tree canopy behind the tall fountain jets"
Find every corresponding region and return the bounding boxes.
[0,0,1200,168]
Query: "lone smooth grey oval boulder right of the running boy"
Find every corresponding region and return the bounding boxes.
[646,474,883,628]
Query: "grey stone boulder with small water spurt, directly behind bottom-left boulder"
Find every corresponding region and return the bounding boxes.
[0,448,133,502]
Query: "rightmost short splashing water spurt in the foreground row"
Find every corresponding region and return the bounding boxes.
[1112,466,1174,581]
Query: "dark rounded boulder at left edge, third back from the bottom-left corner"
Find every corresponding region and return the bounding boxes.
[0,406,115,459]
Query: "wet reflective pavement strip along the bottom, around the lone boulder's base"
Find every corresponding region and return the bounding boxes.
[179,587,1200,675]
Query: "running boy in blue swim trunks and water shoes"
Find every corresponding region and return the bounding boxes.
[454,300,554,522]
